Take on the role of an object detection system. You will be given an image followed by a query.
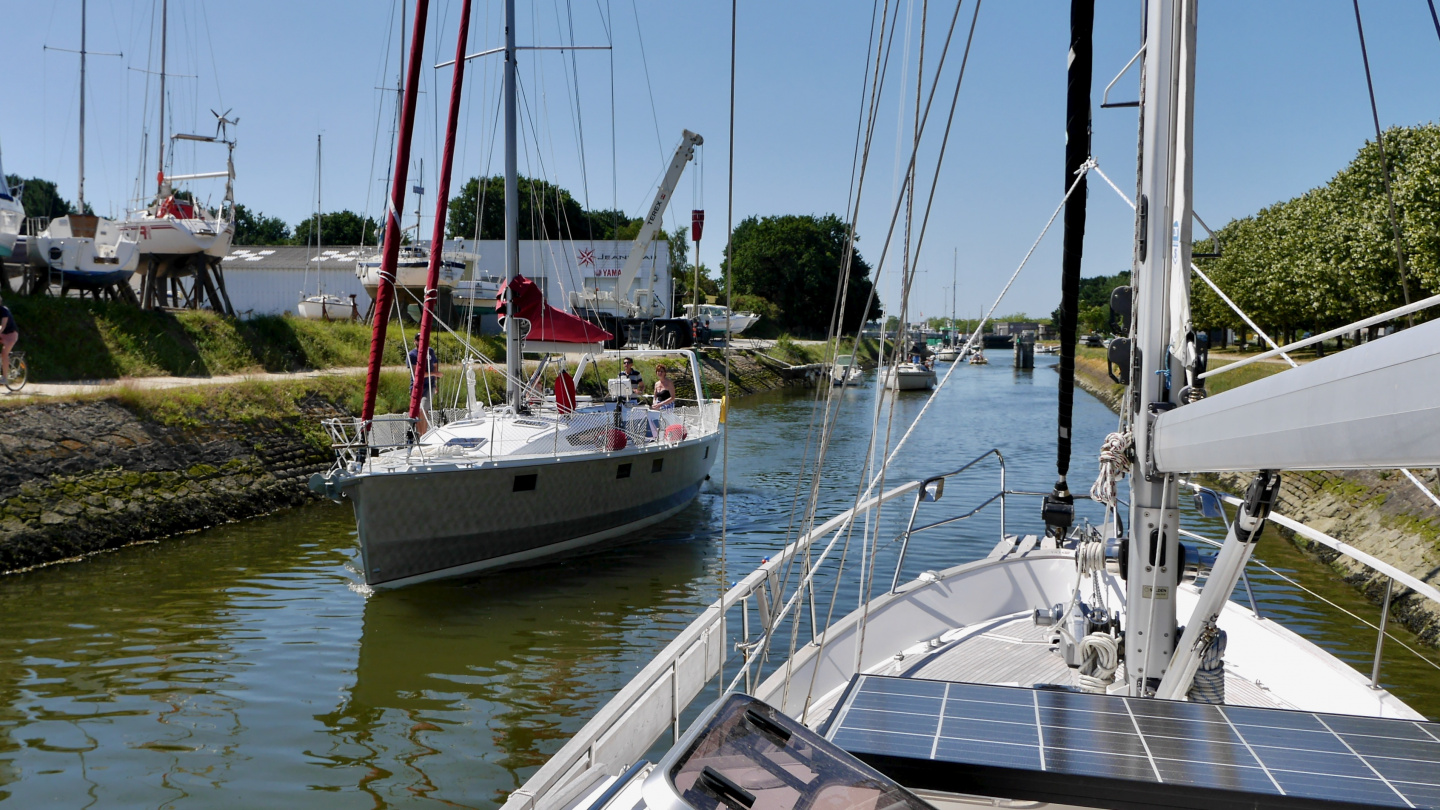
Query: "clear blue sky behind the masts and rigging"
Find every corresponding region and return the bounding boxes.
[0,0,1440,314]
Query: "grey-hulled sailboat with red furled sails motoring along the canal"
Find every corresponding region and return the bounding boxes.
[311,0,721,587]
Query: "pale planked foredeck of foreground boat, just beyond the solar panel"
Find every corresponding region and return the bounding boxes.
[901,617,1295,709]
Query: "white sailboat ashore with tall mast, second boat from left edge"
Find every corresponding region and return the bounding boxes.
[26,0,138,290]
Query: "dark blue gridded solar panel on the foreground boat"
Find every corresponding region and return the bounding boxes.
[825,676,1440,810]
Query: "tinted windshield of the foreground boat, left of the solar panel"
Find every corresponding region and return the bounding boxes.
[668,695,933,810]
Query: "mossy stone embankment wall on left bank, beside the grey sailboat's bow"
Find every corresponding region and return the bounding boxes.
[0,396,341,571]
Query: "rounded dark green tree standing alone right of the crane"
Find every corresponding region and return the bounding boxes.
[726,213,880,334]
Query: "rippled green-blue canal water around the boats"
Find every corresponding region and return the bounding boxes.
[0,357,1440,809]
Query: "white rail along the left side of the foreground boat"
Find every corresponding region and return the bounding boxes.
[503,481,920,810]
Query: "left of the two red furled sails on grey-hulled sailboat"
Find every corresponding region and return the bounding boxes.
[360,0,429,431]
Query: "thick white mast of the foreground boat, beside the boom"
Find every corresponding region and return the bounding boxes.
[1125,0,1195,695]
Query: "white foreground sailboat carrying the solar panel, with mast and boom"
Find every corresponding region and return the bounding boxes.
[505,0,1440,810]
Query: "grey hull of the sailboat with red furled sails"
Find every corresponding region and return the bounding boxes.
[346,434,719,587]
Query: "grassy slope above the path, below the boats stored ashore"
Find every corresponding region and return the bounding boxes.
[6,295,504,382]
